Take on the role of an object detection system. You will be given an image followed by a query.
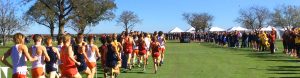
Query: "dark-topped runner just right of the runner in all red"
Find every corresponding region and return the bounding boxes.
[73,33,92,78]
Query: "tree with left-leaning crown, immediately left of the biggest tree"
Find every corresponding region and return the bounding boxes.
[26,2,57,37]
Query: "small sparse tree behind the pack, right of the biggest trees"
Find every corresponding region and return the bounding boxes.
[117,11,141,32]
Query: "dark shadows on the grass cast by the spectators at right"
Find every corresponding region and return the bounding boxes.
[202,43,300,78]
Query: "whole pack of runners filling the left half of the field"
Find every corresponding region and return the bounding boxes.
[1,31,166,78]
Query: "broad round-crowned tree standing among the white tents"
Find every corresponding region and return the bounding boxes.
[182,13,214,32]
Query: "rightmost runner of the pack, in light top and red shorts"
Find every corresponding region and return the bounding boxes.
[157,31,166,66]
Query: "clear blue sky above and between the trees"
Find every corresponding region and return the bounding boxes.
[15,0,300,34]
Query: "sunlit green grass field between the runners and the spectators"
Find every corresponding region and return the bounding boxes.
[0,41,300,78]
